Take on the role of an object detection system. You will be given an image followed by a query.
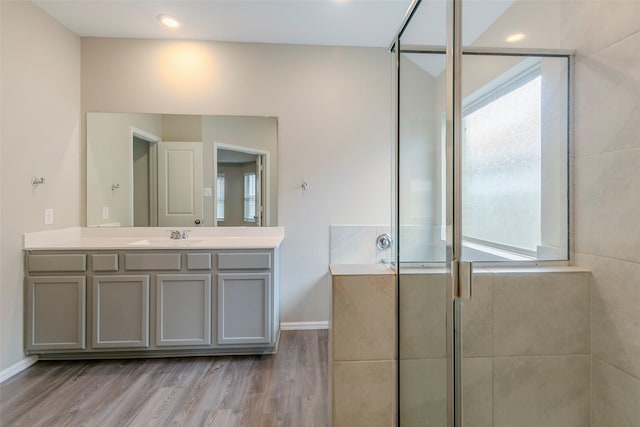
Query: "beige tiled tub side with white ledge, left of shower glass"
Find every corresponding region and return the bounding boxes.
[329,264,397,427]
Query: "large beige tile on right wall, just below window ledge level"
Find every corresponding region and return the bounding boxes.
[576,254,640,378]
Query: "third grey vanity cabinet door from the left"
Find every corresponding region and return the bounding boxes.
[156,274,211,347]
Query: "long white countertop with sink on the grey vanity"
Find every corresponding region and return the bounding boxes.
[24,227,284,250]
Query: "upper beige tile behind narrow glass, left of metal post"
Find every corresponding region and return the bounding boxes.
[399,274,446,359]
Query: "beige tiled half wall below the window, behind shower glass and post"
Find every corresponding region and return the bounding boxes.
[399,267,592,427]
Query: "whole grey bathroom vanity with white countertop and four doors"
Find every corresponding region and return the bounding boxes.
[24,227,284,359]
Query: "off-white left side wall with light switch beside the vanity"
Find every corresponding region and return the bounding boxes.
[0,2,82,373]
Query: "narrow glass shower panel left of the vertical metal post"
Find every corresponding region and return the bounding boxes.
[395,1,453,427]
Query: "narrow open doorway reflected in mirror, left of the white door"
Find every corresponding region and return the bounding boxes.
[131,129,160,227]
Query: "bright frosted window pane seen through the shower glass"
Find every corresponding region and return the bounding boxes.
[462,67,542,257]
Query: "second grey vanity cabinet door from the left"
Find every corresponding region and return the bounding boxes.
[91,275,149,348]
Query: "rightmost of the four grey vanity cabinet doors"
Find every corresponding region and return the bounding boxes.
[218,272,272,345]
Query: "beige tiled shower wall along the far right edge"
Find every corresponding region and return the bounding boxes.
[574,2,640,427]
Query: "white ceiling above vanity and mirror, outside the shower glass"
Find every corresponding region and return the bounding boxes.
[35,0,410,47]
